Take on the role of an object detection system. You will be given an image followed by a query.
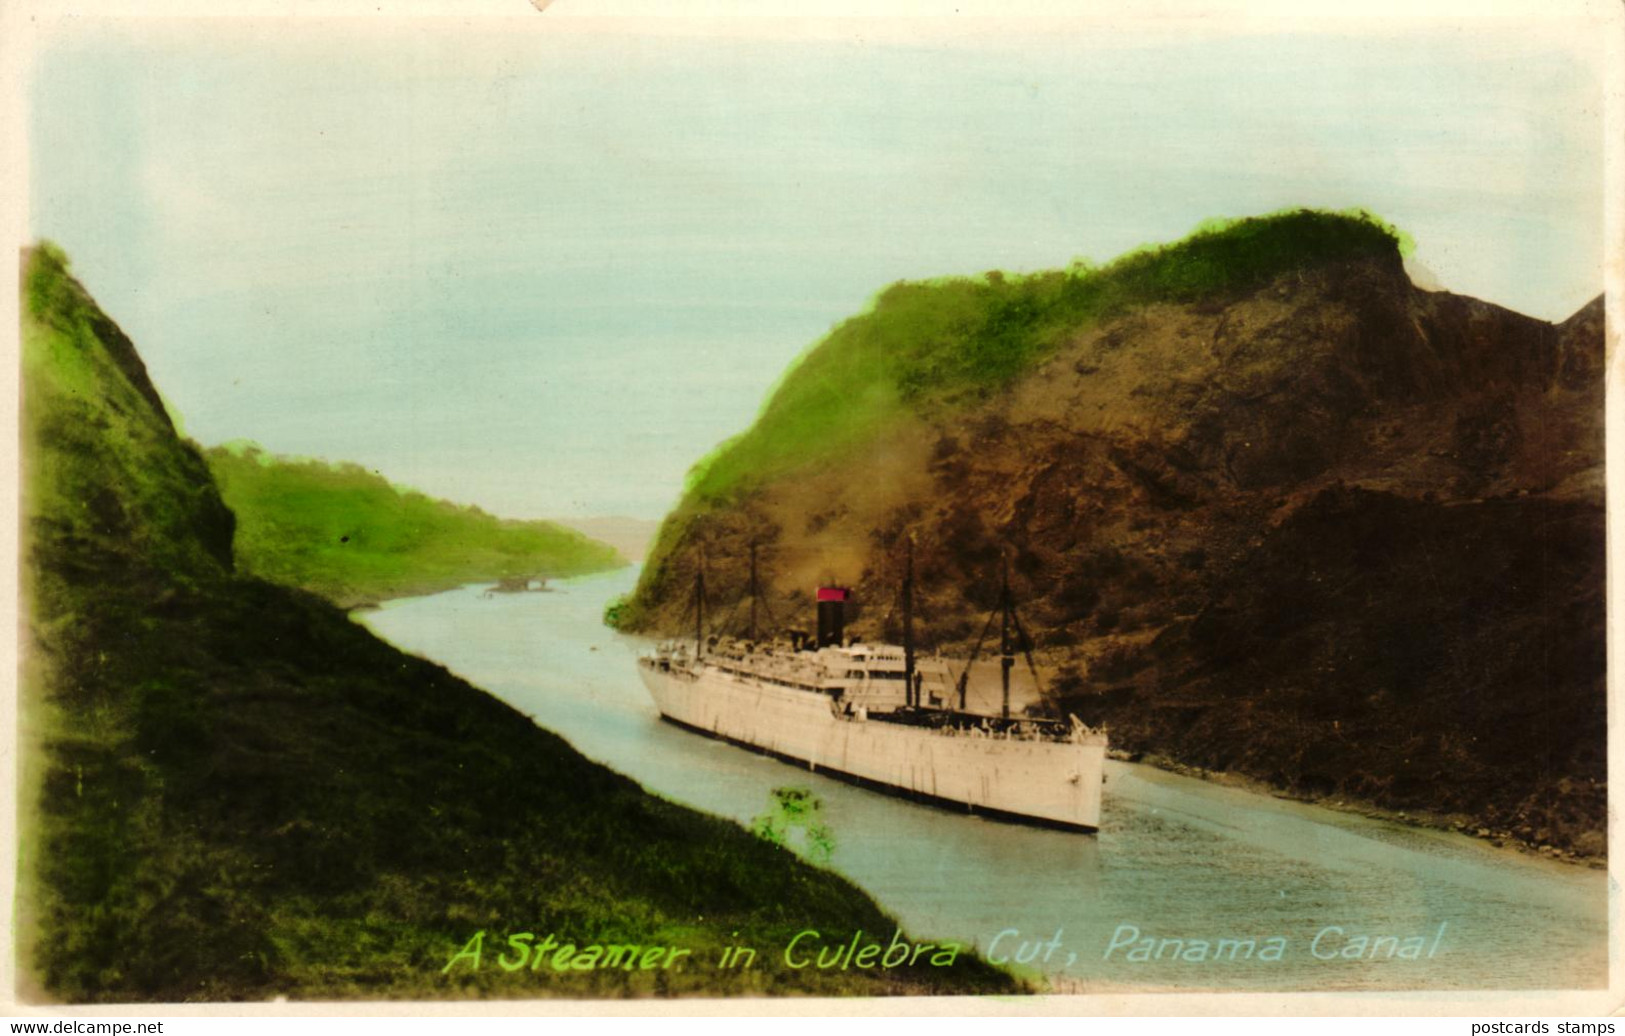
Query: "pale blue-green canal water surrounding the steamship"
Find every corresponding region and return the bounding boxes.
[358,570,1609,992]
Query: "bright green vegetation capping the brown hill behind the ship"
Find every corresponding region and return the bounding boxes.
[684,209,1409,508]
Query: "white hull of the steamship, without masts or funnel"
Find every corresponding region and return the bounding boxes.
[639,666,1107,831]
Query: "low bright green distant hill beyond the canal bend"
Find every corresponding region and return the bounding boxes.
[203,443,626,606]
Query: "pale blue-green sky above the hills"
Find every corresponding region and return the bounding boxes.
[29,6,1604,518]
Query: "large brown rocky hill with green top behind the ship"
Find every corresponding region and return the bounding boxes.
[621,213,1606,853]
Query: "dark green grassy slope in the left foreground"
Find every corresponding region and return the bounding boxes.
[18,247,1012,1002]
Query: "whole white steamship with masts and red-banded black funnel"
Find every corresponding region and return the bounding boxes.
[639,550,1107,831]
